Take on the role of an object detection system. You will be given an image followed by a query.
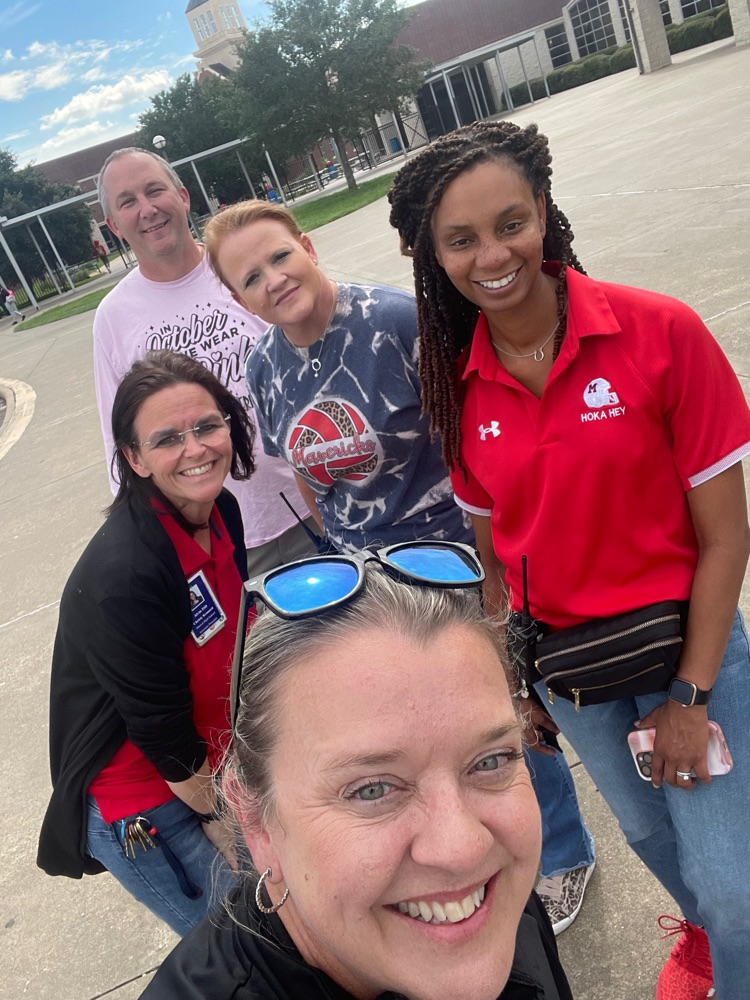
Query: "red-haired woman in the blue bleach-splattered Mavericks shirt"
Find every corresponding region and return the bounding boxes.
[205,201,594,934]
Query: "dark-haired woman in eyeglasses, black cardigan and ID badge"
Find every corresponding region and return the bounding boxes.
[37,351,254,934]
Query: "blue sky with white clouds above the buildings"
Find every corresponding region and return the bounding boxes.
[0,0,267,166]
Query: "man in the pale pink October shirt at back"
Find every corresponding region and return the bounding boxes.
[94,148,315,573]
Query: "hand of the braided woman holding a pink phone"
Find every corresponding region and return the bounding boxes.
[636,699,711,792]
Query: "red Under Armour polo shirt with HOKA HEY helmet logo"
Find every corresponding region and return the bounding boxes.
[451,264,750,628]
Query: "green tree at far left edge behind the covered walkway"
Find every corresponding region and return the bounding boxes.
[0,149,93,292]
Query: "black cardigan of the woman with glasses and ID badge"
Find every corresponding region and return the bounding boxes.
[37,490,247,878]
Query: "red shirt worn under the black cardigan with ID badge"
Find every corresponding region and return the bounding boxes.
[89,507,242,823]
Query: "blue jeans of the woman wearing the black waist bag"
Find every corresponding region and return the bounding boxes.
[536,611,750,1000]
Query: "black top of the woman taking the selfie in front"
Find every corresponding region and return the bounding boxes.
[141,888,573,1000]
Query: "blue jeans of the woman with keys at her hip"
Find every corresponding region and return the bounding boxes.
[86,796,237,936]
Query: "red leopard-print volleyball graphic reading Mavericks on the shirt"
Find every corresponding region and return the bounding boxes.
[286,397,383,486]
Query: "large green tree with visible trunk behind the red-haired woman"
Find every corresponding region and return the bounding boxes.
[225,0,426,190]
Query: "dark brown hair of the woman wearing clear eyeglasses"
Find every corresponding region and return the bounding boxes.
[106,351,255,533]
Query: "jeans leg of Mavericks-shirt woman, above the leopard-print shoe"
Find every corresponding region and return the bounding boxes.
[526,750,594,878]
